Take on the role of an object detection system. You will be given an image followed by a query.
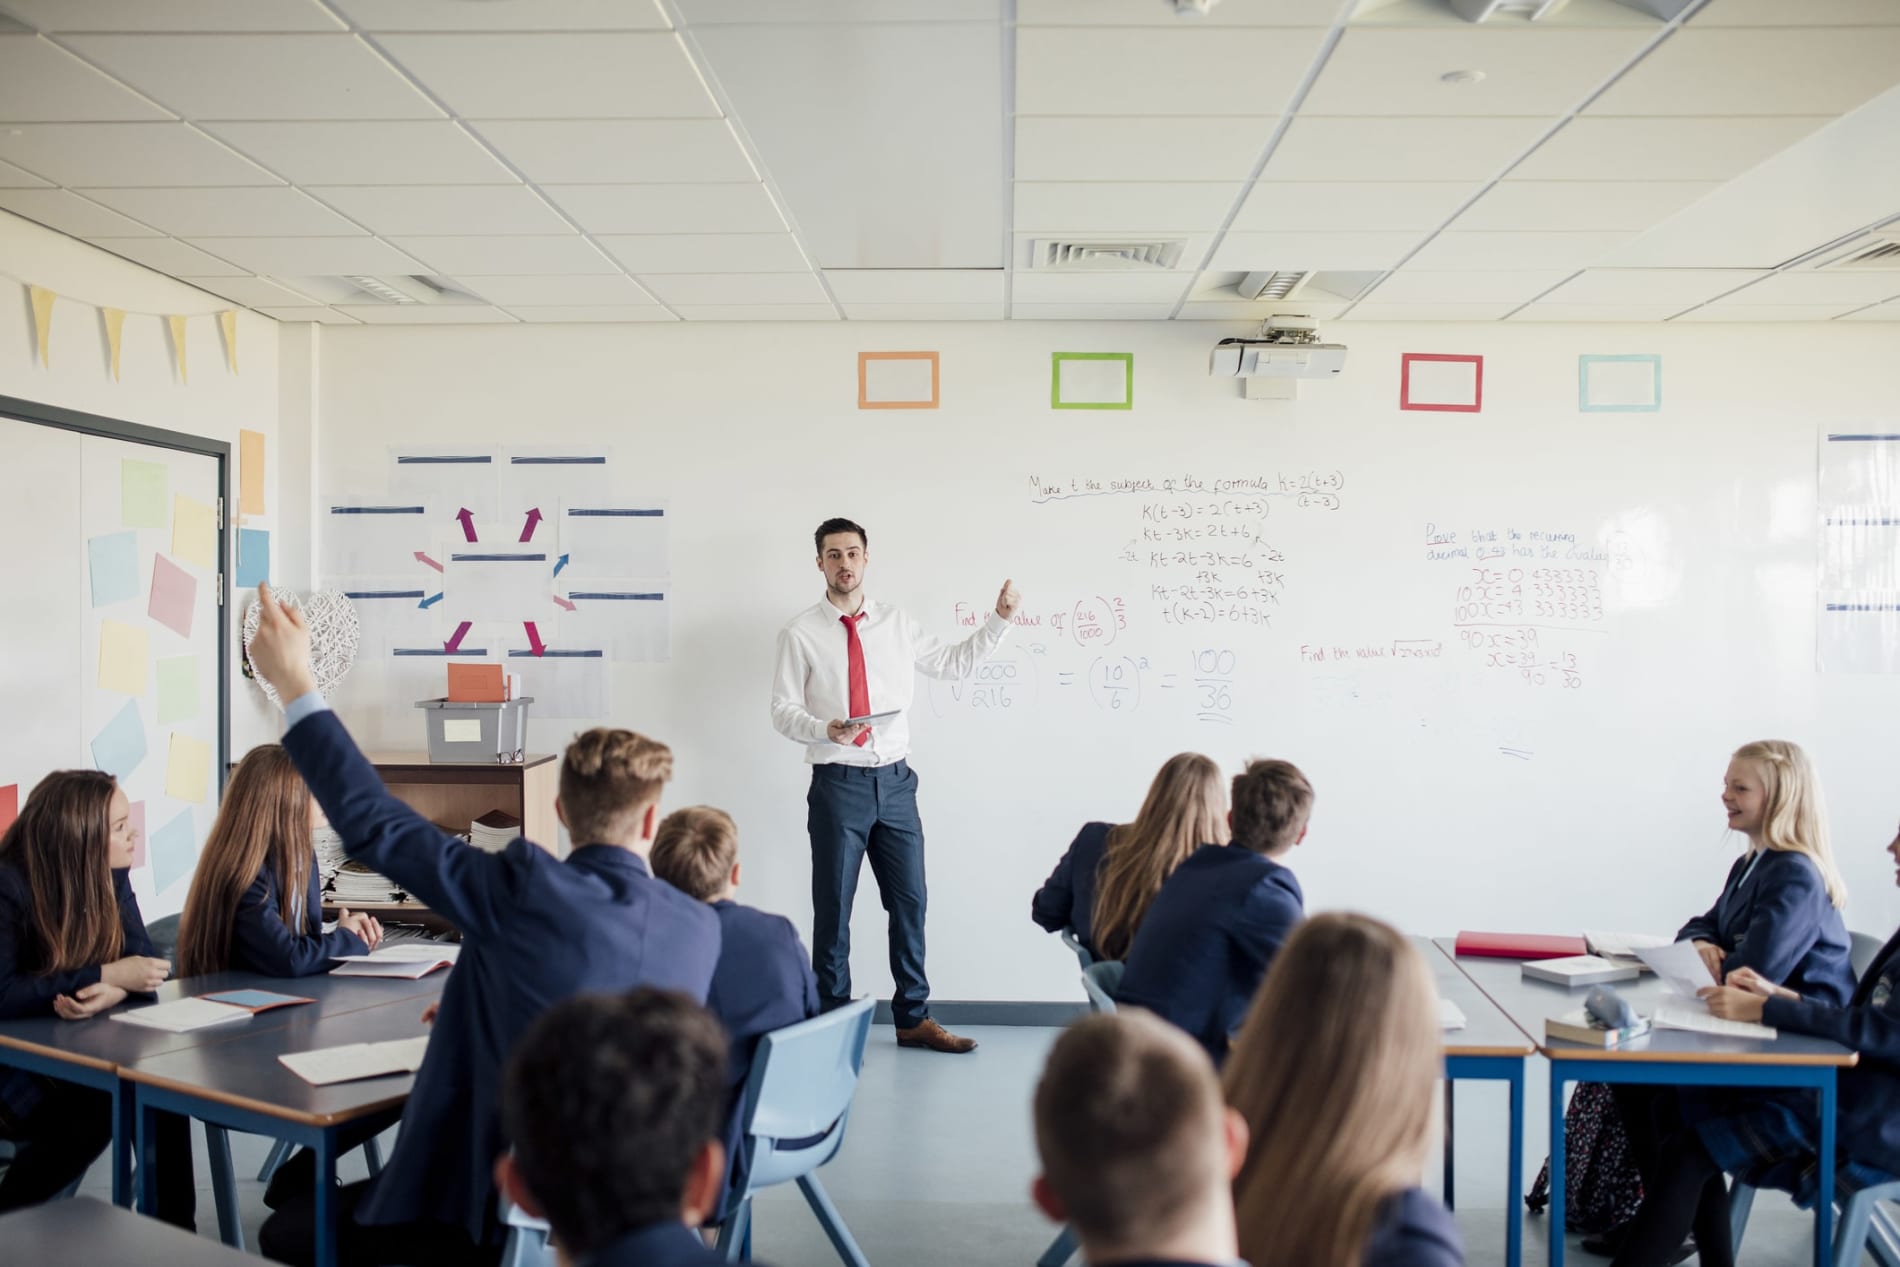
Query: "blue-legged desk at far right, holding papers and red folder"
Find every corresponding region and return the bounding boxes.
[1438,938,1860,1267]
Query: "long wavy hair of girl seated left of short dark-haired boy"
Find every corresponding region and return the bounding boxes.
[1094,752,1227,959]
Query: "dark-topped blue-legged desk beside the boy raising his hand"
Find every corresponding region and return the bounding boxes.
[124,973,447,1267]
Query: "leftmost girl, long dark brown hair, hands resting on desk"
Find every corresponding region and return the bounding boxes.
[0,769,198,1227]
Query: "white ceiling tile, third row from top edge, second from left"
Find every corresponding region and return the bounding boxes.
[203,120,515,184]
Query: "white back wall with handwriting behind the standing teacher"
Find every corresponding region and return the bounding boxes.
[317,321,1900,999]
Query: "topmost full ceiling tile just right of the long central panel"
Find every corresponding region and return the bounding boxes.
[1017,25,1326,116]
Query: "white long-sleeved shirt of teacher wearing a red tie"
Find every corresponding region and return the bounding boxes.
[771,598,1009,766]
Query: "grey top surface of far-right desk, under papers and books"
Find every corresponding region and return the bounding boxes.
[1436,936,1860,1066]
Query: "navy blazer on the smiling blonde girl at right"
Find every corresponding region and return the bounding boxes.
[1676,849,1854,1007]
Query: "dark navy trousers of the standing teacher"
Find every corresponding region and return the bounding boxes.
[806,762,931,1030]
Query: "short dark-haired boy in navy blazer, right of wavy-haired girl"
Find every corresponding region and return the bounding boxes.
[1115,760,1313,1066]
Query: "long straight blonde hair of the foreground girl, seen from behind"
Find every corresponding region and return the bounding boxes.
[1226,914,1440,1267]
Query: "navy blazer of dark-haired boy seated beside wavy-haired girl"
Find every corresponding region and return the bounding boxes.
[1115,845,1305,1066]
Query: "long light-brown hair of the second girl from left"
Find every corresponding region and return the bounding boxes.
[179,743,315,976]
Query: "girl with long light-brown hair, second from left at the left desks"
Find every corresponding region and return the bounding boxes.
[179,743,382,976]
